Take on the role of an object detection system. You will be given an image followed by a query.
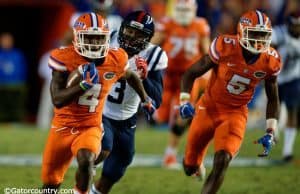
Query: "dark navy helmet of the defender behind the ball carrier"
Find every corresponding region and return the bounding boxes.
[118,11,154,56]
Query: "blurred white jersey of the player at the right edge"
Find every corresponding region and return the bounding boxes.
[272,25,300,84]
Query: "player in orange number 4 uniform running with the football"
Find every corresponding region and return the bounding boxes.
[42,13,152,193]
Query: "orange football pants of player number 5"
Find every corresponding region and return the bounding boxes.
[184,97,247,166]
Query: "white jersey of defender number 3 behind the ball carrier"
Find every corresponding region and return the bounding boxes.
[103,31,168,120]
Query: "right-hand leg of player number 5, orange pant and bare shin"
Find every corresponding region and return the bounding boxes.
[201,110,247,194]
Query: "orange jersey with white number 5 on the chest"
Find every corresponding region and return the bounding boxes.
[204,35,281,107]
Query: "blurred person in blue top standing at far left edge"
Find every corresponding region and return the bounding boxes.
[0,32,27,121]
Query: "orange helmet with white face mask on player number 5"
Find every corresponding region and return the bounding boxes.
[237,10,272,54]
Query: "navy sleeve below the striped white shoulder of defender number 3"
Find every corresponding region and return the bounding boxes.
[143,70,163,108]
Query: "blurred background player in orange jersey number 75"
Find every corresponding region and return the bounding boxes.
[152,0,210,168]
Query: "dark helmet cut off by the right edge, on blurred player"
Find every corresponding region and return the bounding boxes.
[287,11,300,38]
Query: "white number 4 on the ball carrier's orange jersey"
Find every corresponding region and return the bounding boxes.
[78,84,101,112]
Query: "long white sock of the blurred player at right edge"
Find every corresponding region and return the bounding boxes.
[282,128,297,157]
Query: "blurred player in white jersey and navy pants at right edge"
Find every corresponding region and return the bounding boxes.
[272,12,300,162]
